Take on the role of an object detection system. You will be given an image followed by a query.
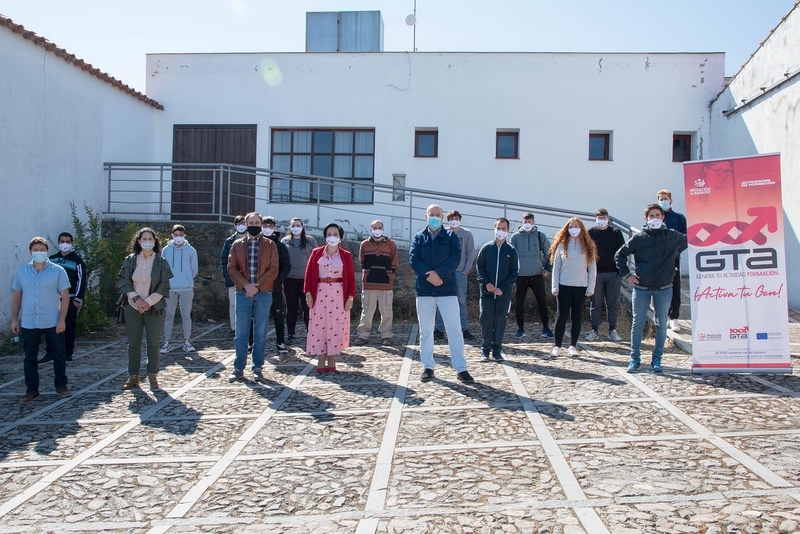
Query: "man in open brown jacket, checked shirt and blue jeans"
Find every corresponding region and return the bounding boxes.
[228,212,278,380]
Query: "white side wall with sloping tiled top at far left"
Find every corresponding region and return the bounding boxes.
[0,27,158,328]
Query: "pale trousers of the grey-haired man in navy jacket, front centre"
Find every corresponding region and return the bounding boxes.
[417,297,467,373]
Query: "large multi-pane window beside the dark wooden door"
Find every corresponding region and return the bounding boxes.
[270,127,375,204]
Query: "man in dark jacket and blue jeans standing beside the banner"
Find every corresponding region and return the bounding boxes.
[614,204,686,373]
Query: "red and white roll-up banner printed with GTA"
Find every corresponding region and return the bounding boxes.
[683,154,792,373]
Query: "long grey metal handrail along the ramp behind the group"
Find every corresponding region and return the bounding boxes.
[102,162,639,242]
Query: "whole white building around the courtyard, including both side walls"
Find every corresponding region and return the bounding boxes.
[0,6,800,324]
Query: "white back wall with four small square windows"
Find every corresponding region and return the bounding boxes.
[147,52,724,241]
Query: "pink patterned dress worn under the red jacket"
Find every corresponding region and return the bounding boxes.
[306,251,350,356]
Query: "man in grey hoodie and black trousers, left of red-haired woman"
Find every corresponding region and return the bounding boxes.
[511,212,555,339]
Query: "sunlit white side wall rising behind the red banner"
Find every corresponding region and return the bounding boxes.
[708,5,800,309]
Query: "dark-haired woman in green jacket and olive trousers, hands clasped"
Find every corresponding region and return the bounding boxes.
[119,228,172,389]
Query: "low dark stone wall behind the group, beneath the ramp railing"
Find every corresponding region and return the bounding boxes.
[103,221,556,326]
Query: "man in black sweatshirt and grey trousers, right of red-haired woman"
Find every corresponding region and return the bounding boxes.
[586,208,625,341]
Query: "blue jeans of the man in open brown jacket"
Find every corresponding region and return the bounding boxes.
[233,290,272,371]
